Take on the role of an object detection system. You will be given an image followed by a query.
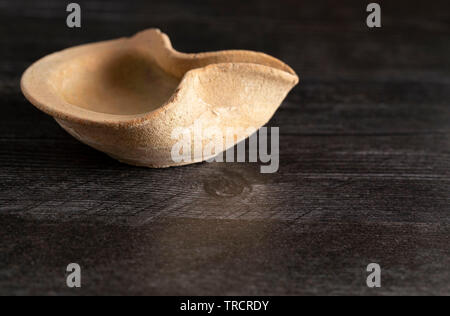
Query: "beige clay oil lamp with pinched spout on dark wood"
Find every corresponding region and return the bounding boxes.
[21,29,298,167]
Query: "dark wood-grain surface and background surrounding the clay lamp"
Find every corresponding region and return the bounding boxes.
[0,0,450,295]
